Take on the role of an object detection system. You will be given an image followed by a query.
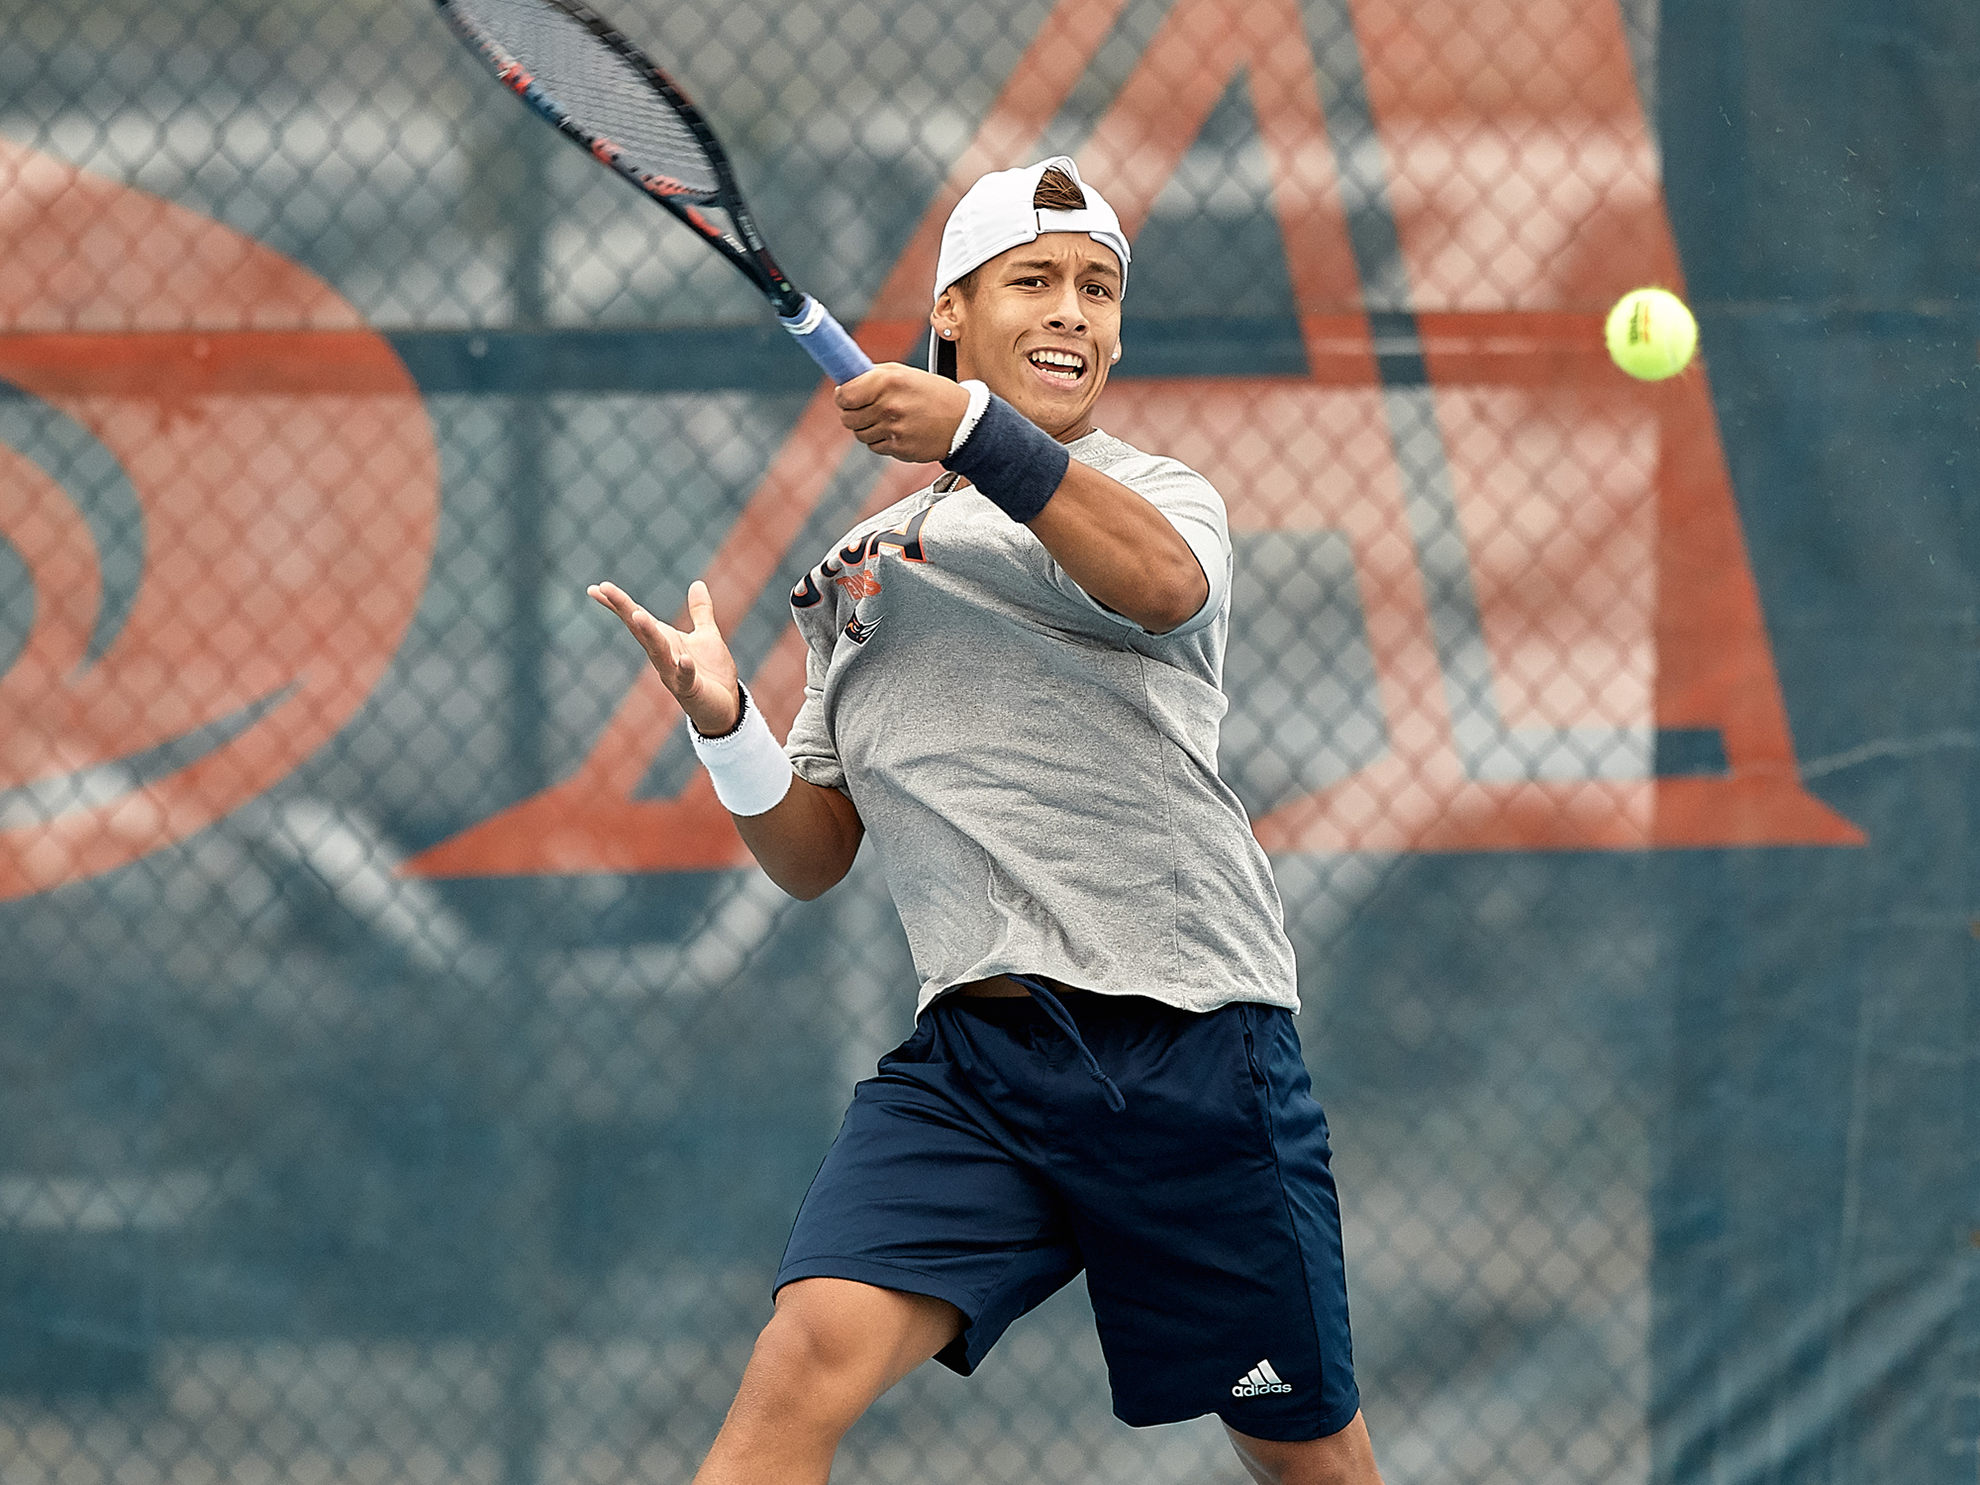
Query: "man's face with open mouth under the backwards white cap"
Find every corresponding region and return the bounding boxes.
[931,232,1121,442]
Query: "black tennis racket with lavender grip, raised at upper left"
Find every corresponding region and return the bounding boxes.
[436,0,873,382]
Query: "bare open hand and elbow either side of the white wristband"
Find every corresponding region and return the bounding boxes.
[588,582,865,901]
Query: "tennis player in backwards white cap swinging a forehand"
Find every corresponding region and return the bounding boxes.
[590,156,1380,1485]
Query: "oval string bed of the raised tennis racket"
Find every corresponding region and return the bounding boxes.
[453,0,721,196]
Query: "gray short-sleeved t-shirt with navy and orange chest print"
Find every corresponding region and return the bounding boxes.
[786,432,1299,1014]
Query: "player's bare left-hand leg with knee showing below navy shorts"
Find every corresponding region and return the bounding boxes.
[695,1279,962,1485]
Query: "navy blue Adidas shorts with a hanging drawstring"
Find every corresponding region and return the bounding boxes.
[776,994,1360,1439]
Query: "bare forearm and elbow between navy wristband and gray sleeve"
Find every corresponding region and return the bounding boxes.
[1026,459,1210,634]
